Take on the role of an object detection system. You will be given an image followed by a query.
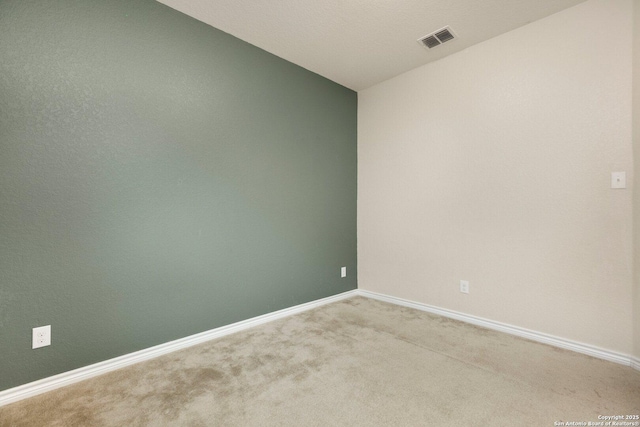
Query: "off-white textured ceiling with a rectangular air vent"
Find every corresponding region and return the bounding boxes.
[159,0,584,90]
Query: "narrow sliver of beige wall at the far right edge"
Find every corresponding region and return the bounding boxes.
[633,0,640,359]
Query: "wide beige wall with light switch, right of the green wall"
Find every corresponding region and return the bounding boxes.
[358,0,633,354]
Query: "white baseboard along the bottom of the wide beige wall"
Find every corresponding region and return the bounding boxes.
[356,289,640,371]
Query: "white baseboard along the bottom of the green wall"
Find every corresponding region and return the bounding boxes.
[0,290,356,406]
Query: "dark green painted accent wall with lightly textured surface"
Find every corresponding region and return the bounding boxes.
[0,0,357,390]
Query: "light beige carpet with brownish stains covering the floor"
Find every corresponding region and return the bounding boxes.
[0,297,640,427]
